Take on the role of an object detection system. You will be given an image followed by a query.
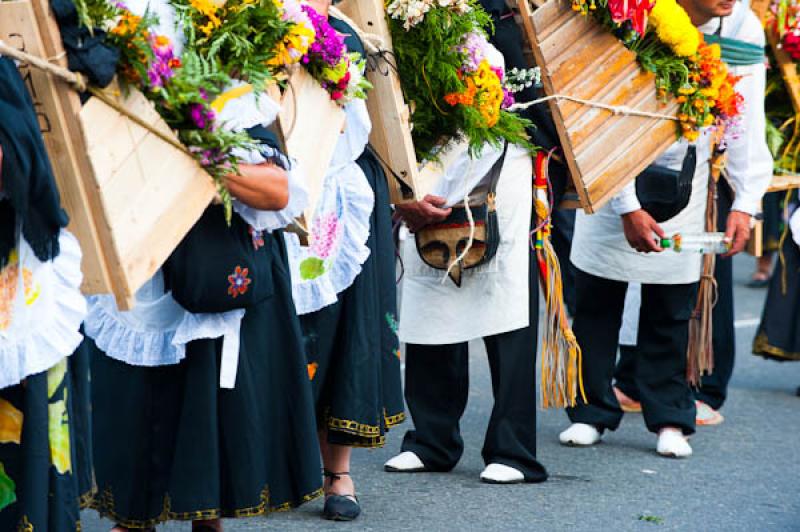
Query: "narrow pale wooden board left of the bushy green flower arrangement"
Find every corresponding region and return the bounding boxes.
[336,0,419,204]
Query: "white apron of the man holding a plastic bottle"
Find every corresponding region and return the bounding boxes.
[570,132,711,284]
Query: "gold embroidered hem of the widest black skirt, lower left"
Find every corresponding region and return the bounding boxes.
[91,487,322,528]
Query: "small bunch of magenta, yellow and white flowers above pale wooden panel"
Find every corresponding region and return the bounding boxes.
[301,5,372,105]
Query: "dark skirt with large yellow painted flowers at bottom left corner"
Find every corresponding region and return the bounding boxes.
[0,350,91,532]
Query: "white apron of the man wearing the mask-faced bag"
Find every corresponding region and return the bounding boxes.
[398,146,533,345]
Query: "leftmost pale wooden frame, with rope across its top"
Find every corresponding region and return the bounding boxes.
[0,0,215,310]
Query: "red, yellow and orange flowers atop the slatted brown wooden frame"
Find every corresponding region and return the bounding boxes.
[572,0,743,141]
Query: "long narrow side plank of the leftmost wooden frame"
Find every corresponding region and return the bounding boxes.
[0,0,112,294]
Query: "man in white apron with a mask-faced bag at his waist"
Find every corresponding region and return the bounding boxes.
[384,28,547,484]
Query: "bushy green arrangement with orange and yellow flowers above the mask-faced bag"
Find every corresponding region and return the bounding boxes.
[387,0,534,160]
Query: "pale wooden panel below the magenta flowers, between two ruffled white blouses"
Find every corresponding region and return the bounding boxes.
[279,68,346,222]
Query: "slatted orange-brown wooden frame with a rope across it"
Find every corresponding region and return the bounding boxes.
[518,0,678,213]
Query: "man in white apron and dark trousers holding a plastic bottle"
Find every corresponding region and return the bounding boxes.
[559,0,772,458]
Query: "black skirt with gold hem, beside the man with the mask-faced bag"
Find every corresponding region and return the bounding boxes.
[300,152,405,447]
